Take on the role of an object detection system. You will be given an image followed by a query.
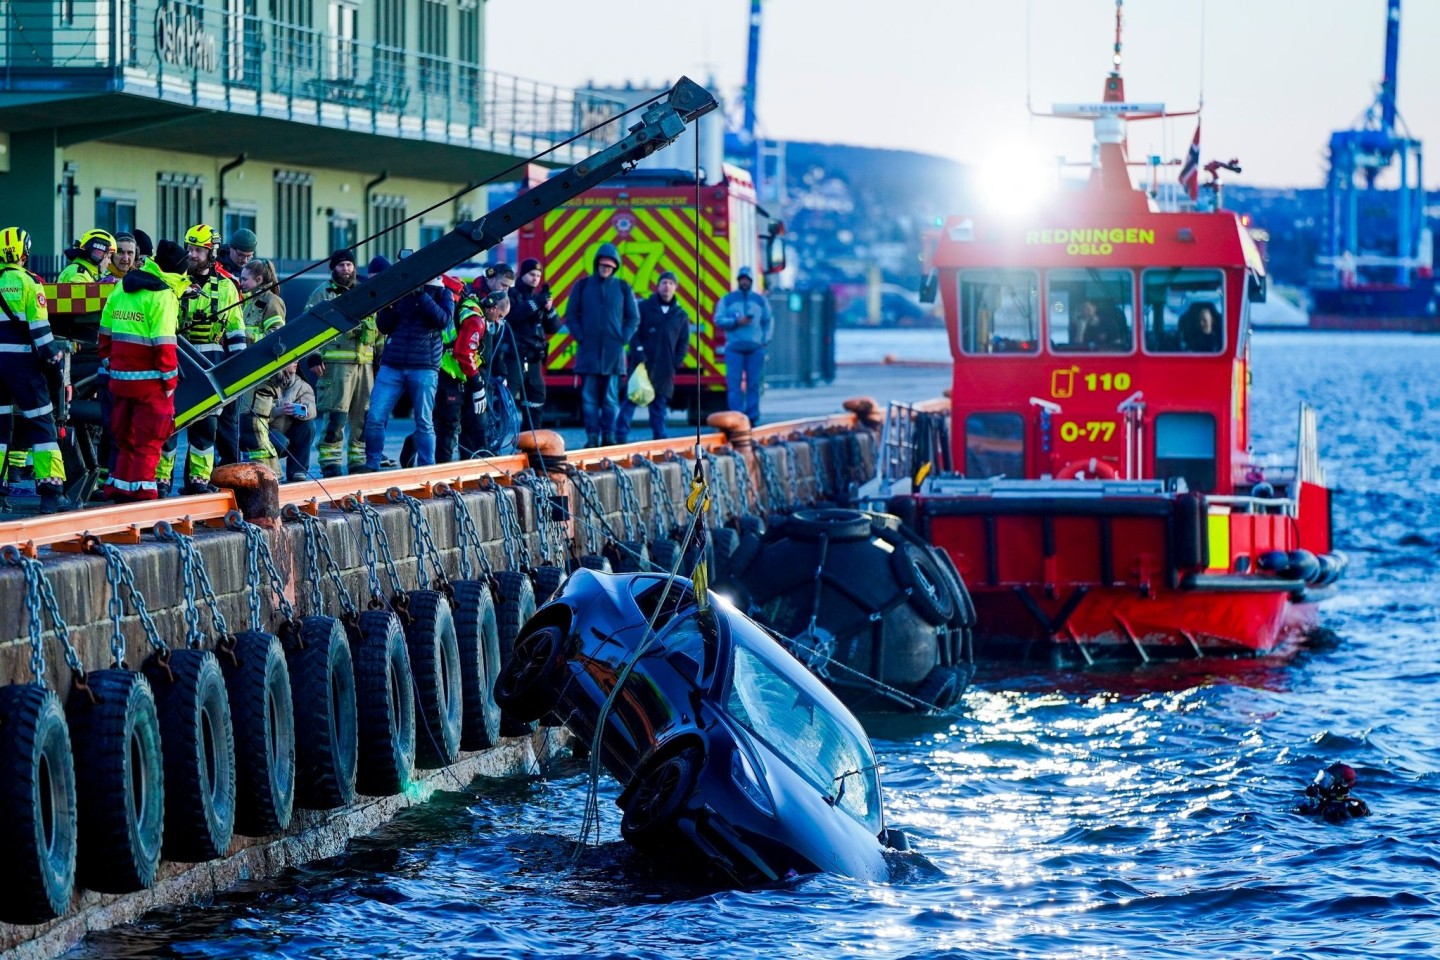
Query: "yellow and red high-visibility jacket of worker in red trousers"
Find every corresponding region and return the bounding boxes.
[99,261,190,397]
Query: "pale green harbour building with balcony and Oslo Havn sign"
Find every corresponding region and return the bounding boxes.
[0,0,624,273]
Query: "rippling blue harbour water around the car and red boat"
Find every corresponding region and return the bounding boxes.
[72,332,1440,960]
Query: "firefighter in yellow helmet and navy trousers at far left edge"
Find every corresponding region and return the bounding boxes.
[0,227,65,514]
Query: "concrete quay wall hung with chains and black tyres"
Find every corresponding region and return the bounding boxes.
[0,426,877,959]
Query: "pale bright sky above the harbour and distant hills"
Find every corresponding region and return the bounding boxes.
[485,0,1440,189]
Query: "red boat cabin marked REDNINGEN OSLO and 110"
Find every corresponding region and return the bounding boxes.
[933,207,1264,494]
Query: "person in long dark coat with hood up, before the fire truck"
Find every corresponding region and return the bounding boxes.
[564,243,639,446]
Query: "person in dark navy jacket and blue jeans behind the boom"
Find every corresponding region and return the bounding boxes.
[364,258,455,471]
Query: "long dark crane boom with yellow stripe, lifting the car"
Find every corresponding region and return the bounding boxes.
[174,76,717,430]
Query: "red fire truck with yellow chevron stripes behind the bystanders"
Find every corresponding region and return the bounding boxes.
[518,164,785,415]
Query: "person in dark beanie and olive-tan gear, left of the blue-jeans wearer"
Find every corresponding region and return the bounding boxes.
[305,249,377,476]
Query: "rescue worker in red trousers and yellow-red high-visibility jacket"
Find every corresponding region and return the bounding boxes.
[99,240,190,502]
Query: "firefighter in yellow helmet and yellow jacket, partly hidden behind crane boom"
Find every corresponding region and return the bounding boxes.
[156,223,246,497]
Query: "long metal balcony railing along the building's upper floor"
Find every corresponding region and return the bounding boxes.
[0,0,624,161]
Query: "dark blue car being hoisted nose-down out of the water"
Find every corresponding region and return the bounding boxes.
[495,570,904,885]
